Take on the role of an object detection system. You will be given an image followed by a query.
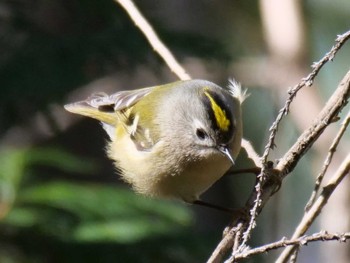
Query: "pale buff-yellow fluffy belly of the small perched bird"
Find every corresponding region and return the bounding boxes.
[109,136,231,203]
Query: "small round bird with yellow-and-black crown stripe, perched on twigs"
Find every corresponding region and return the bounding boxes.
[64,79,245,209]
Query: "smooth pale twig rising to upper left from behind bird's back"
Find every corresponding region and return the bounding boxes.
[114,0,191,80]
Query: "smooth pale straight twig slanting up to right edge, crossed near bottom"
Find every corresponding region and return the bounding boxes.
[276,154,350,263]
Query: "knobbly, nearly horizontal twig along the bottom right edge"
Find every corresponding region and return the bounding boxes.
[229,231,350,262]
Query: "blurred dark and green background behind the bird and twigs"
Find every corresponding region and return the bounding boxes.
[0,0,350,263]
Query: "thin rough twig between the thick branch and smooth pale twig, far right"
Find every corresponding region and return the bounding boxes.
[305,111,350,211]
